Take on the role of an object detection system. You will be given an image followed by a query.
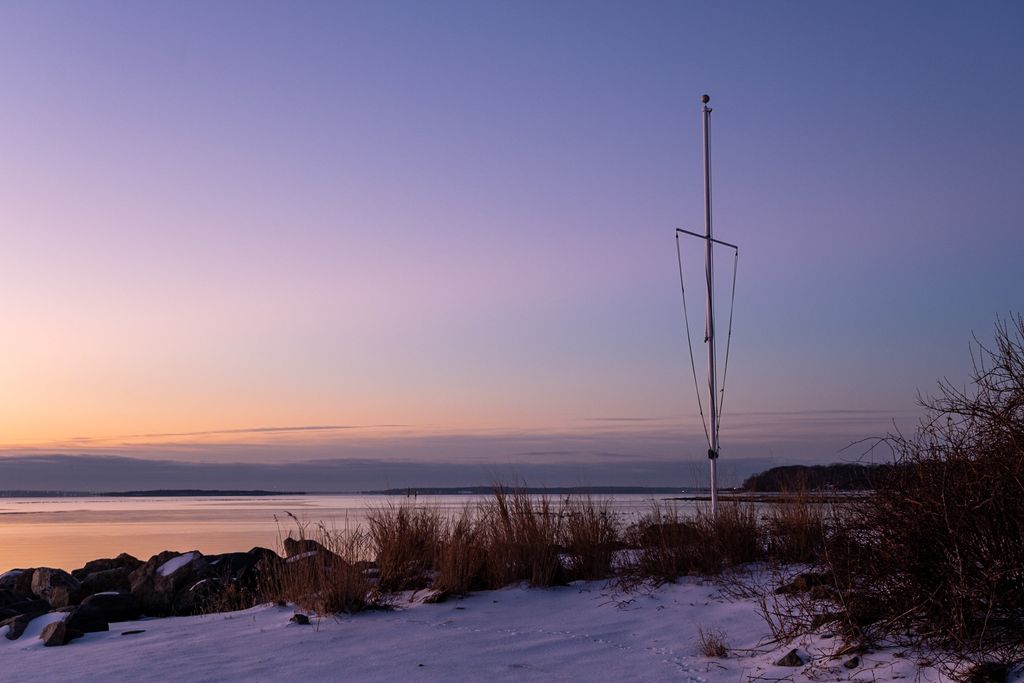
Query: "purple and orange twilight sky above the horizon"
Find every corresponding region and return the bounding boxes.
[0,1,1024,489]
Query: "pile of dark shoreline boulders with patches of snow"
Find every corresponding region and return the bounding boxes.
[0,539,339,646]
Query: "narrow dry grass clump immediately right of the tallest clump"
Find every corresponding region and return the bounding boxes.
[560,496,623,580]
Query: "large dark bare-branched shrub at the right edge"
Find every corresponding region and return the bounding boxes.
[827,316,1024,661]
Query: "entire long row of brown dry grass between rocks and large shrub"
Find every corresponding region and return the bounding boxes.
[251,487,843,613]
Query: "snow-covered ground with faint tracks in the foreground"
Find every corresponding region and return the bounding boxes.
[0,580,987,683]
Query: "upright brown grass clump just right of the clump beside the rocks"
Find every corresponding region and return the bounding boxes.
[367,503,443,591]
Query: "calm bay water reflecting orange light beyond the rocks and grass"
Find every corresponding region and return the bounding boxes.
[0,495,679,572]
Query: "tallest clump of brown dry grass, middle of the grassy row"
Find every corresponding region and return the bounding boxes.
[479,487,565,587]
